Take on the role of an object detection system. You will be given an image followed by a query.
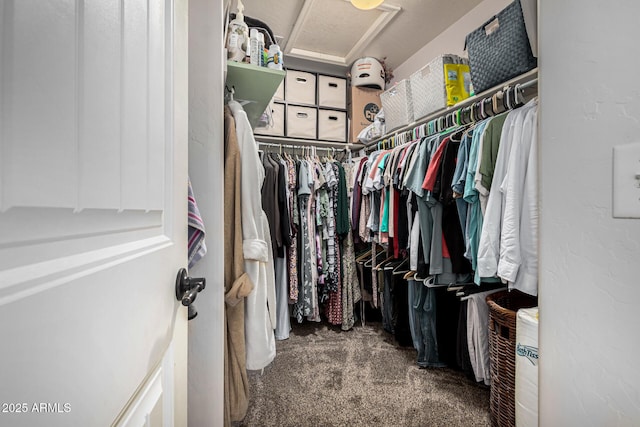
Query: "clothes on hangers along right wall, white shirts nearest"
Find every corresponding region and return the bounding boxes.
[351,84,537,383]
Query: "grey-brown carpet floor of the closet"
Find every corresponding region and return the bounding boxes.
[238,323,490,427]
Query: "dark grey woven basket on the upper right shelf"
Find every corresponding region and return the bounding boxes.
[465,0,538,94]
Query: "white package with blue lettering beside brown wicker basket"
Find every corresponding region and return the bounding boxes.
[515,307,538,427]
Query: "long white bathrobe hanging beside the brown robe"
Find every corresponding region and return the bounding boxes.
[228,101,276,370]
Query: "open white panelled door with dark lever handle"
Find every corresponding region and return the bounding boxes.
[0,0,187,426]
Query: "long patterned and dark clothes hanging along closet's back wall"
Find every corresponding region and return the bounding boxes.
[262,144,360,340]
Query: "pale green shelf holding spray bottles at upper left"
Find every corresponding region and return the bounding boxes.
[226,61,286,128]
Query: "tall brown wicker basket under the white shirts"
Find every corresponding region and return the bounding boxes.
[487,291,538,427]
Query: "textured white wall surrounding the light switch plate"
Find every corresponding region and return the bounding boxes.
[539,0,640,426]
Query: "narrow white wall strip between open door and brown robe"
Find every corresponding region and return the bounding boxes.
[184,0,226,427]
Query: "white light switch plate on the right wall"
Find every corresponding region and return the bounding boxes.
[613,143,640,218]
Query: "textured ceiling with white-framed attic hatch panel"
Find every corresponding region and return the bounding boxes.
[231,0,482,68]
